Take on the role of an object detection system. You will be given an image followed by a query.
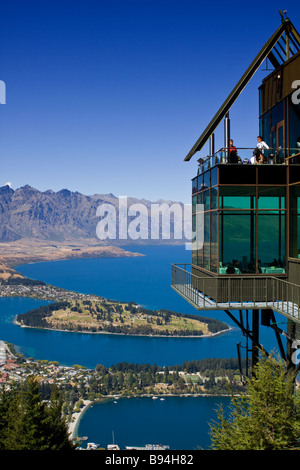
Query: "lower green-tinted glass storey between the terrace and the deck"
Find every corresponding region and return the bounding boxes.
[192,165,290,275]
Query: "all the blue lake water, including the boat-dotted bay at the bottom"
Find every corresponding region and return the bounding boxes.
[0,246,284,449]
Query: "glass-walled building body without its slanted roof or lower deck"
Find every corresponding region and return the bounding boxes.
[192,46,300,277]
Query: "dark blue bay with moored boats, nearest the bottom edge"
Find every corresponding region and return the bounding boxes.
[79,397,230,450]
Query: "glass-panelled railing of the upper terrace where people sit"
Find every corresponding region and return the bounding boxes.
[198,147,300,171]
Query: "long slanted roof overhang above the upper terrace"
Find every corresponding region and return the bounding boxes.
[184,19,300,161]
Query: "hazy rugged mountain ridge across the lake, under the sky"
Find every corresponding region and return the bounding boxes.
[0,185,189,245]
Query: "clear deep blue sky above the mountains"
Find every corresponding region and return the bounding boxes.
[0,0,300,203]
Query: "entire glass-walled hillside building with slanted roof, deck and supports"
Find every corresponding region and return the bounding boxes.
[171,16,300,370]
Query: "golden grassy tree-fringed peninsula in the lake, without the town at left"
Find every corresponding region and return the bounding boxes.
[17,299,229,336]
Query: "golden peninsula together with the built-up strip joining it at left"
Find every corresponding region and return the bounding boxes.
[0,278,229,337]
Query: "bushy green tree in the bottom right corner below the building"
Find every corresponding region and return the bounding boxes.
[210,357,300,450]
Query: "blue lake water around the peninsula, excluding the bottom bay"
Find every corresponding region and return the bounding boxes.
[12,246,284,368]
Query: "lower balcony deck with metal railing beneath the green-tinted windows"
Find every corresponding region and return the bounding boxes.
[171,264,300,321]
